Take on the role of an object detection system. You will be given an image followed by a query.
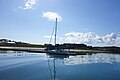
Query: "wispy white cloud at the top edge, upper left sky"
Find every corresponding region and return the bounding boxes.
[18,0,38,10]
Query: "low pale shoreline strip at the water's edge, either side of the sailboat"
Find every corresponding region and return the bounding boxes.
[0,46,120,55]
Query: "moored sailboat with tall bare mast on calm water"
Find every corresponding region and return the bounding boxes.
[47,18,68,55]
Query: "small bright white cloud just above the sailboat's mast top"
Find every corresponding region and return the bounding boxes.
[42,12,62,21]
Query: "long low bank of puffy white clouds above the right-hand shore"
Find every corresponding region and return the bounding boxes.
[64,32,120,45]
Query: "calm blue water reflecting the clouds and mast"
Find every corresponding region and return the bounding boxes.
[0,52,120,80]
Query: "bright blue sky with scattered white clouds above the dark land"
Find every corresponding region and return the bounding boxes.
[0,0,120,46]
